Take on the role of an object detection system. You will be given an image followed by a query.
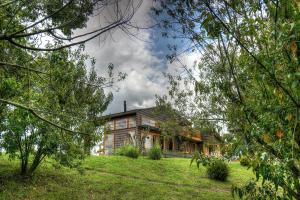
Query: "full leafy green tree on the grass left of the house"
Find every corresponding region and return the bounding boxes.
[0,47,118,176]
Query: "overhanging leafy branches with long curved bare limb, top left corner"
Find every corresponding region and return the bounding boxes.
[0,0,141,51]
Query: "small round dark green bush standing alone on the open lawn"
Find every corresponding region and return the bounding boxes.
[207,160,229,181]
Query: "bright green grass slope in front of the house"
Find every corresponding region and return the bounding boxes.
[0,156,253,200]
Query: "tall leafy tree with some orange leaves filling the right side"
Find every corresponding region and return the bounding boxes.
[154,0,300,199]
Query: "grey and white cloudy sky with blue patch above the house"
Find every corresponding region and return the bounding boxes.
[78,0,197,113]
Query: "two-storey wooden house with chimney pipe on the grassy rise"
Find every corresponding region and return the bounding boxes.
[103,101,220,156]
